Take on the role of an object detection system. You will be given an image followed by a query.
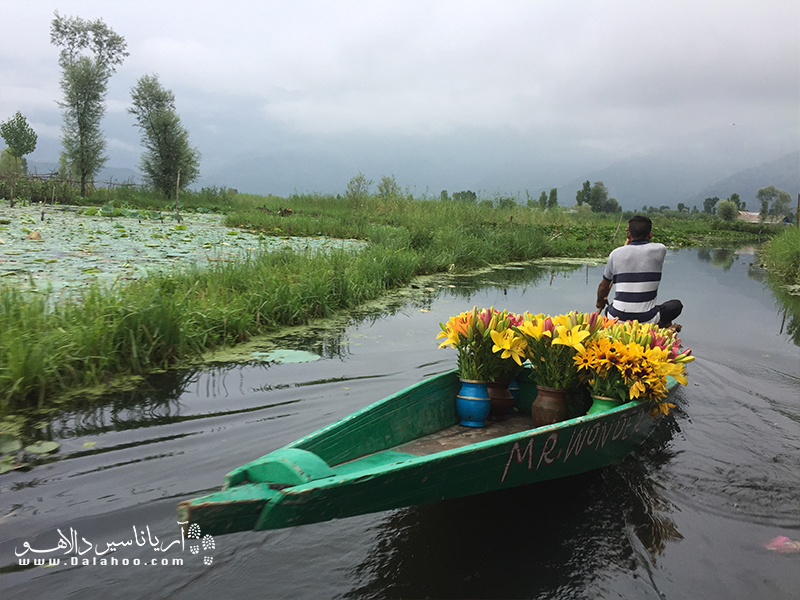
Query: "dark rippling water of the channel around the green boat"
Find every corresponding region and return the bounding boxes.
[0,249,800,600]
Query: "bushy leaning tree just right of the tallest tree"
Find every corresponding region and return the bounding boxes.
[128,75,200,198]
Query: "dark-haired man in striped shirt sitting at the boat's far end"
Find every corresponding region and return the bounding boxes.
[596,215,683,327]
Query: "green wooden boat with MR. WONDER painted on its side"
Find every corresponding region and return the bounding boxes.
[178,370,676,535]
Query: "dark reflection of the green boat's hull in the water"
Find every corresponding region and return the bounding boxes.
[345,410,683,599]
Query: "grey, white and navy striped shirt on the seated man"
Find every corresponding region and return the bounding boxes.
[603,240,667,323]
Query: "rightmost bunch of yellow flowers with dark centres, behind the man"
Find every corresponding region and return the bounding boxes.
[573,321,694,415]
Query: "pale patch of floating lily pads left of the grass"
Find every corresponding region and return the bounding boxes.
[0,206,365,301]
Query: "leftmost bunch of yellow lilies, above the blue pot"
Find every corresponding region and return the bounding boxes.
[436,307,525,381]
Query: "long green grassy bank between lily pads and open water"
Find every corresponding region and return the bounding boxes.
[0,190,780,413]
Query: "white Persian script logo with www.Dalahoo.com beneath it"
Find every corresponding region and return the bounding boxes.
[14,521,216,567]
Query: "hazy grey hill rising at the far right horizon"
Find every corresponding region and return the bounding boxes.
[684,151,800,210]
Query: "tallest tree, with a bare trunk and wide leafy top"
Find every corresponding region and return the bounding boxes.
[50,11,128,196]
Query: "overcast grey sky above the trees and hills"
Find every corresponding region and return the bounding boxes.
[0,0,800,195]
